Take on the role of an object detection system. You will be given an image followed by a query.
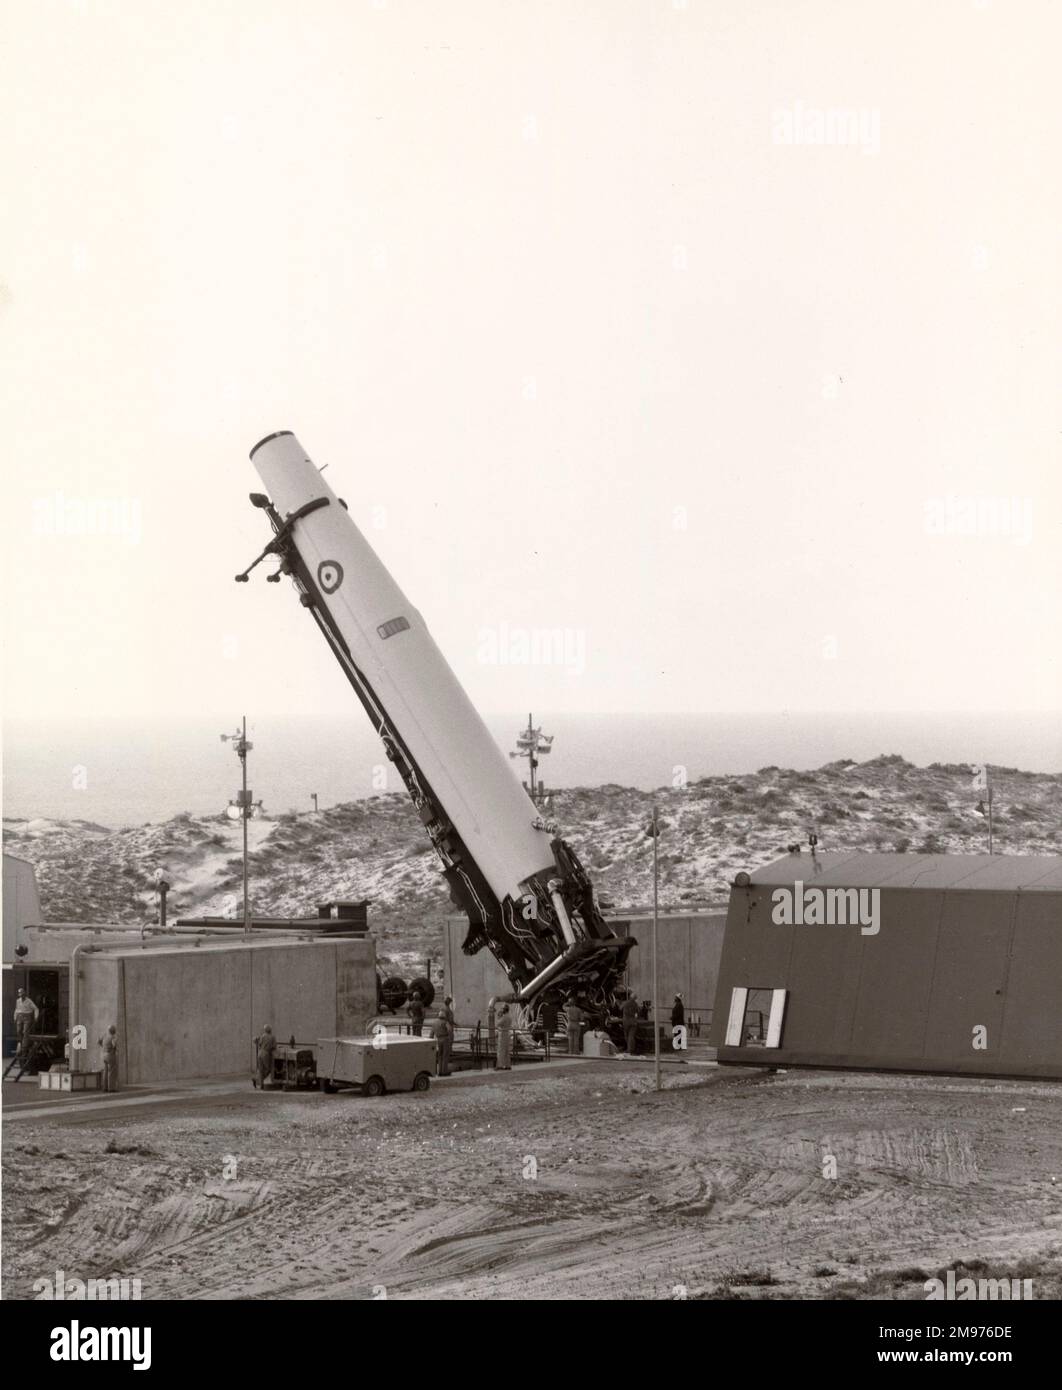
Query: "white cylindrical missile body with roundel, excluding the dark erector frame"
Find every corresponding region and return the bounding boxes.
[252,434,553,901]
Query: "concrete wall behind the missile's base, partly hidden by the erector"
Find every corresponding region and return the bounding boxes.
[443,912,726,1026]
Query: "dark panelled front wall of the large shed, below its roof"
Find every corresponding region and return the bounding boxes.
[710,887,1062,1077]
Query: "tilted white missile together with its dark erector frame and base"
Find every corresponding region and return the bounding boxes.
[236,430,634,1017]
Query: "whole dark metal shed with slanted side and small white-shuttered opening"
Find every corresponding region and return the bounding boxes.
[712,852,1062,1079]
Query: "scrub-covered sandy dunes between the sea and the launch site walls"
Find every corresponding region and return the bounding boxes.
[4,755,1062,955]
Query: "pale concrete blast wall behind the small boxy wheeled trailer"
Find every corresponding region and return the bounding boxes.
[72,938,375,1083]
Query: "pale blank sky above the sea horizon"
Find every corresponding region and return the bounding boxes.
[0,0,1062,719]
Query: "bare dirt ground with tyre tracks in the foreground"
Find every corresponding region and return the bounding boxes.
[3,1063,1062,1298]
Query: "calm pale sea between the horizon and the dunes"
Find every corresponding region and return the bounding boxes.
[3,710,1062,826]
